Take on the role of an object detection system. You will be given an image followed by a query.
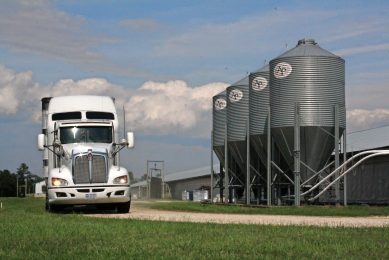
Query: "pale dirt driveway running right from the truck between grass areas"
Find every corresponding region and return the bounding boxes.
[87,202,389,227]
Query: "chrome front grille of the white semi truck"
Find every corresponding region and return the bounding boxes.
[73,154,107,184]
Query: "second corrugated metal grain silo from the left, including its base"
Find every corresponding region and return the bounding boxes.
[227,76,249,199]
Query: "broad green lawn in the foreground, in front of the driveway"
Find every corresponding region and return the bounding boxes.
[0,198,389,259]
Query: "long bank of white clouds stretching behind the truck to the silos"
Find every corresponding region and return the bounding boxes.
[0,66,227,136]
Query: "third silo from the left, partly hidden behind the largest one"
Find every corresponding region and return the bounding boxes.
[249,65,270,171]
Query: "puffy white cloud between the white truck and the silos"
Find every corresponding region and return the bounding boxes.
[125,80,227,136]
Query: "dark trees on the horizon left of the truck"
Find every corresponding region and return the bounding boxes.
[0,163,44,197]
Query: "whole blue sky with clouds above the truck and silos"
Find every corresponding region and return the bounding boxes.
[0,0,389,175]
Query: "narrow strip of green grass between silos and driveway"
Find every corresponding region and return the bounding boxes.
[142,201,389,217]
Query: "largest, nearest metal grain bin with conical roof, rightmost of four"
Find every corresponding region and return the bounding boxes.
[270,39,346,184]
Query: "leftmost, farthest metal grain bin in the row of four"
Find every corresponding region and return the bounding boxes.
[212,91,227,164]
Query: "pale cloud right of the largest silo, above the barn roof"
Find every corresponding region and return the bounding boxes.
[347,109,389,132]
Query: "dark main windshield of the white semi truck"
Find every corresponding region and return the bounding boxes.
[60,126,112,144]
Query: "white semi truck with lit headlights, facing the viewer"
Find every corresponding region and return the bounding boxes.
[38,95,134,213]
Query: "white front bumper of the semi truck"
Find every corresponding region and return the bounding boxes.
[47,185,131,205]
